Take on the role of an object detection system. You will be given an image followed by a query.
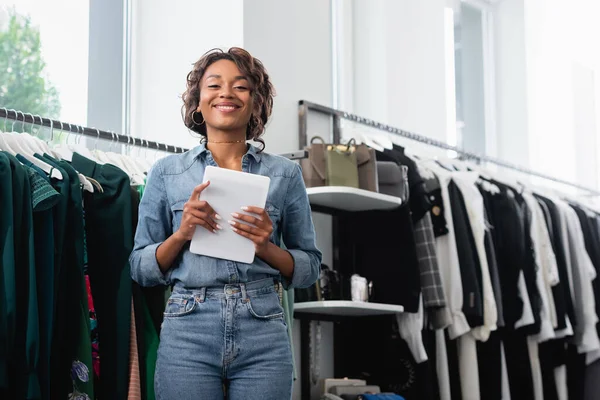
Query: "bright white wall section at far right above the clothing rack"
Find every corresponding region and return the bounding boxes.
[522,0,600,190]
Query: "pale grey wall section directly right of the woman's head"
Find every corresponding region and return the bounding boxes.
[244,0,333,153]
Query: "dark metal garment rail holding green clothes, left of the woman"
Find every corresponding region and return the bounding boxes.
[0,108,188,153]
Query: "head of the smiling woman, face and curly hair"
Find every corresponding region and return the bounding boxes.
[182,47,275,151]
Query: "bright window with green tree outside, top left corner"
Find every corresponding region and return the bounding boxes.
[0,0,89,130]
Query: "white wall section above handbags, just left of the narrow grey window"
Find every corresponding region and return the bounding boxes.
[352,0,446,141]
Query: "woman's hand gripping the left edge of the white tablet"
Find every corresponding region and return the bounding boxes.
[176,181,223,241]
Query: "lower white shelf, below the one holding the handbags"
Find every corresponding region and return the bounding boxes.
[294,300,404,318]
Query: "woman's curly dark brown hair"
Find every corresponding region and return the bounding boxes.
[181,47,275,151]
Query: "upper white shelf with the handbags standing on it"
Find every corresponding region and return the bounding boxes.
[306,186,402,211]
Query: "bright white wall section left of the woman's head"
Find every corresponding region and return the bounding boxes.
[131,0,244,152]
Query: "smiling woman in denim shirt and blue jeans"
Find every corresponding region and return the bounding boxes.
[130,48,321,400]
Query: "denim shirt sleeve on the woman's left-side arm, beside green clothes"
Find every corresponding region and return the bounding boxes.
[129,162,173,286]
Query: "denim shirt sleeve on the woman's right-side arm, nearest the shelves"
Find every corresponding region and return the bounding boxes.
[281,164,322,289]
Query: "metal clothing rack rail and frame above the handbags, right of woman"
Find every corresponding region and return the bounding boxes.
[298,100,600,195]
